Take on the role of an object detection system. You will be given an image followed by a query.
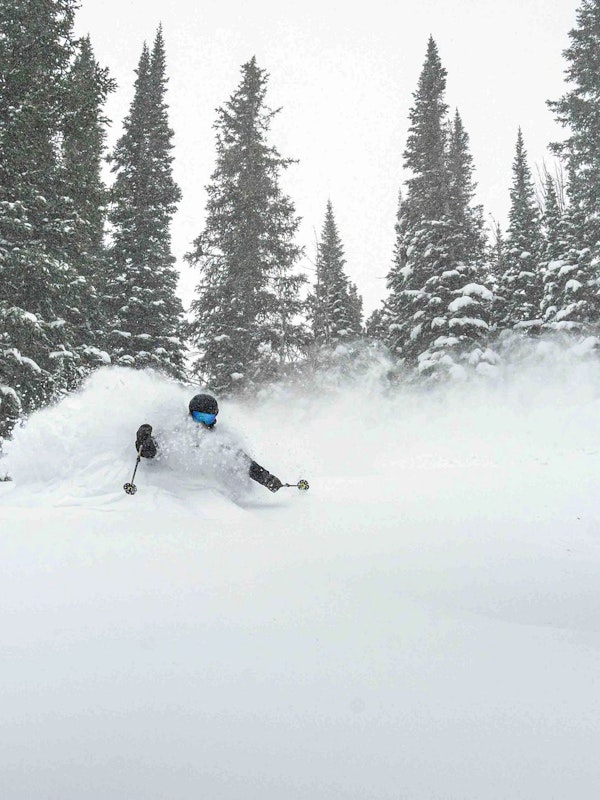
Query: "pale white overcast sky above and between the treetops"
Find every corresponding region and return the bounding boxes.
[76,0,579,312]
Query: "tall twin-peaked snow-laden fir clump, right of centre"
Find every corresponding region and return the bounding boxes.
[382,38,492,382]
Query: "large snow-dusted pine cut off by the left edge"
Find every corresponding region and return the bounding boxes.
[0,0,106,435]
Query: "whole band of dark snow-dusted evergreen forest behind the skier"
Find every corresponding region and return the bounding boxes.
[0,0,600,444]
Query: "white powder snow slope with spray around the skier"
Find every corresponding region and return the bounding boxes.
[0,354,600,800]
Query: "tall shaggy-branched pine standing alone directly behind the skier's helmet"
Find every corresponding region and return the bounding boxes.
[187,58,307,392]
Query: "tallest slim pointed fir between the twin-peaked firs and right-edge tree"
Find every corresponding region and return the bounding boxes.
[498,128,543,330]
